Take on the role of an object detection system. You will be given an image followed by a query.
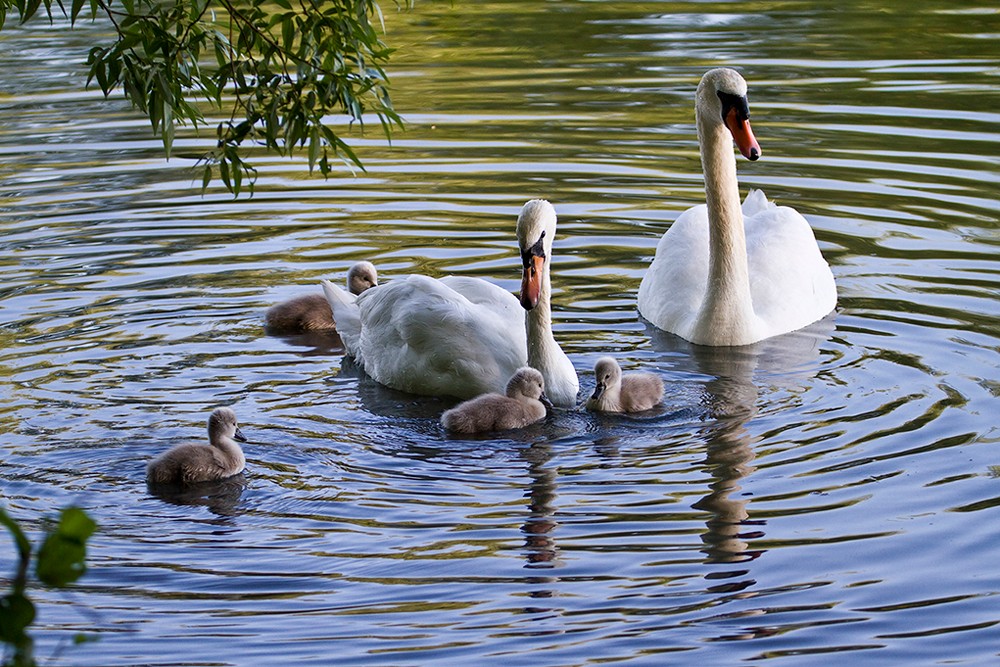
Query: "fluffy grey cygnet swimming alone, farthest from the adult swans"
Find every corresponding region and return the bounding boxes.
[146,408,247,484]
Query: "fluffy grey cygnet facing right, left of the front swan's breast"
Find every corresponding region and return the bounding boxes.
[441,366,552,433]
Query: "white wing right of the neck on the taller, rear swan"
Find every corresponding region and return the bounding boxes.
[745,196,837,336]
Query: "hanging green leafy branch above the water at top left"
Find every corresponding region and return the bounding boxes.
[0,0,402,195]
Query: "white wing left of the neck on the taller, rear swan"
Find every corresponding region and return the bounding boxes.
[638,204,708,338]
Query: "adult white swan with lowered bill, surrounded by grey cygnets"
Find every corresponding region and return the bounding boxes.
[323,199,579,407]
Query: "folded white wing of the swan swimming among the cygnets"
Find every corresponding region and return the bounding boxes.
[358,276,527,398]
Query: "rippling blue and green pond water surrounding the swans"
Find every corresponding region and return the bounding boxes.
[0,0,1000,665]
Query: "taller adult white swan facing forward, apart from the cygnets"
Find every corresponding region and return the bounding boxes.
[639,68,837,345]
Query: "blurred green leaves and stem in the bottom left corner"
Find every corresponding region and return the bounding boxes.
[0,507,97,667]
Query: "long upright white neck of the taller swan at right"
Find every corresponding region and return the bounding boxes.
[692,107,757,345]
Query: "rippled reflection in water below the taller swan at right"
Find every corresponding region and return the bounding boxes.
[646,315,834,563]
